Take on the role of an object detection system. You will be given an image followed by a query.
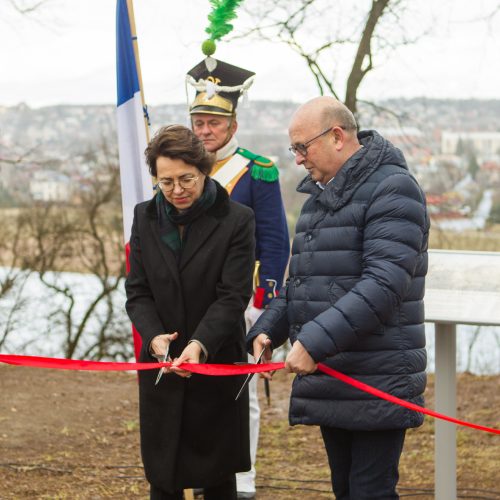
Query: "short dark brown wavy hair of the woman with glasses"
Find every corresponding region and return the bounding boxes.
[144,125,215,177]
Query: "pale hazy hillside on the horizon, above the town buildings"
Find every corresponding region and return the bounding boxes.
[0,98,500,156]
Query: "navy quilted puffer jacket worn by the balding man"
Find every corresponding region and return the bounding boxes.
[247,131,429,430]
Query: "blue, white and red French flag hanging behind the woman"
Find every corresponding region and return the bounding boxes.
[116,0,153,359]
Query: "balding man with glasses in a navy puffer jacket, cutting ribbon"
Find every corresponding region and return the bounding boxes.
[247,97,429,500]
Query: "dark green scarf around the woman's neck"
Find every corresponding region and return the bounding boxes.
[156,177,217,262]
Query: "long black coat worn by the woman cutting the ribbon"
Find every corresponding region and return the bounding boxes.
[125,185,255,491]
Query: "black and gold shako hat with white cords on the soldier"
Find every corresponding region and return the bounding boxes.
[186,57,255,116]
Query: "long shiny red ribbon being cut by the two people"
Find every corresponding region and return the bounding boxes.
[0,354,500,434]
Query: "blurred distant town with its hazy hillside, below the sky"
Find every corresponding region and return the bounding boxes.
[0,98,500,227]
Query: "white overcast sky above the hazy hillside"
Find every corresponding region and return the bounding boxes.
[0,0,500,107]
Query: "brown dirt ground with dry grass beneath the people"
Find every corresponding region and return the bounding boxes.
[0,365,500,500]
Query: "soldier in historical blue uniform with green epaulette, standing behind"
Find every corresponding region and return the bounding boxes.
[187,57,290,498]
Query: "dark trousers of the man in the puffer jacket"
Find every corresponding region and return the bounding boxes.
[321,427,406,500]
